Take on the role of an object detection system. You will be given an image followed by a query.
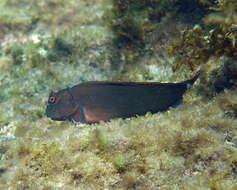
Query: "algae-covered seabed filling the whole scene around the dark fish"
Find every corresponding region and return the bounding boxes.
[0,0,237,190]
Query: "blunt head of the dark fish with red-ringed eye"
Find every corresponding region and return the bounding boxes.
[45,89,77,121]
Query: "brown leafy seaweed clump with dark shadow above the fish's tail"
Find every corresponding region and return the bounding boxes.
[168,0,237,97]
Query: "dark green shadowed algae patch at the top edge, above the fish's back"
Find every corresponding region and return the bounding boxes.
[109,0,214,48]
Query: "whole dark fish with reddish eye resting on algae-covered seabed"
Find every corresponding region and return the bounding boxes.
[46,72,200,123]
